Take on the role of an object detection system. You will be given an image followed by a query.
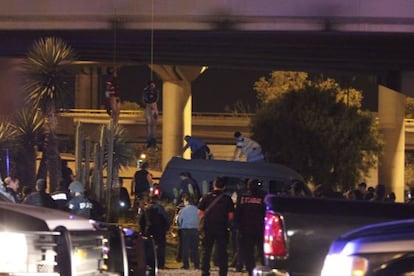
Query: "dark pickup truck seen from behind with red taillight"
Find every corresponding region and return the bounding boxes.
[253,194,414,276]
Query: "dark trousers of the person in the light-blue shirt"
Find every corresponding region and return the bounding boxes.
[181,228,200,269]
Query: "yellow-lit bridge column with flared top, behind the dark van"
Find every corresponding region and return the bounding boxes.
[151,65,205,169]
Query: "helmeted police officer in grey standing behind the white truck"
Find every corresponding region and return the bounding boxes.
[67,181,92,218]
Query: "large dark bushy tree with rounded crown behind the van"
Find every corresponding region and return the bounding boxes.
[252,83,381,192]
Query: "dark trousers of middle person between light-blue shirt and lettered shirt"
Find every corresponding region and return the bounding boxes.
[201,230,229,276]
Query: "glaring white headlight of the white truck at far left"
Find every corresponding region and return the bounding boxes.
[0,232,27,272]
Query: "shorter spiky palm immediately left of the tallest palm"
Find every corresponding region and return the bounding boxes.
[11,108,44,189]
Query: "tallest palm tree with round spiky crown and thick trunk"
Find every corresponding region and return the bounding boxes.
[24,37,75,191]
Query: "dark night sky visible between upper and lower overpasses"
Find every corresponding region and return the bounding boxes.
[119,65,378,112]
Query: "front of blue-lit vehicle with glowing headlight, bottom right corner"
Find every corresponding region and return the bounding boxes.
[321,219,414,276]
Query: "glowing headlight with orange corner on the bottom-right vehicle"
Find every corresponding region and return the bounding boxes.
[321,255,368,276]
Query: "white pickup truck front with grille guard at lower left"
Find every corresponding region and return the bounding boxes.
[0,193,157,276]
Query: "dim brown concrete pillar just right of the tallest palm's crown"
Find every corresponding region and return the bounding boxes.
[74,65,100,108]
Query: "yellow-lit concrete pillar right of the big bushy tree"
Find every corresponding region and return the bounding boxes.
[378,85,406,202]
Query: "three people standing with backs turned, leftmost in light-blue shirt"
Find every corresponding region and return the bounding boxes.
[171,177,265,275]
